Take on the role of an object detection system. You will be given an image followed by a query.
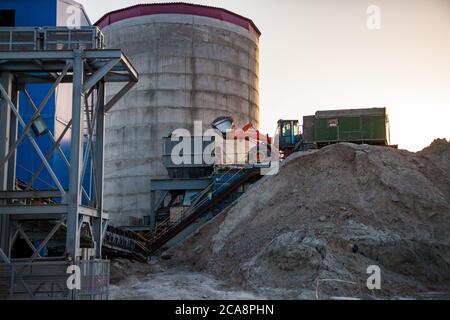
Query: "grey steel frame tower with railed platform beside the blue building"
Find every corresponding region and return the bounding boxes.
[0,27,138,298]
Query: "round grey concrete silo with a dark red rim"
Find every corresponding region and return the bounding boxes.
[97,3,260,225]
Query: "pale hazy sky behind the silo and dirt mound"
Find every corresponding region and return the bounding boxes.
[78,0,450,151]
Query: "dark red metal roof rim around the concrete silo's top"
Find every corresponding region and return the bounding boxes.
[95,2,261,36]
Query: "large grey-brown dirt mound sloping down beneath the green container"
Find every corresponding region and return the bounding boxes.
[171,140,450,298]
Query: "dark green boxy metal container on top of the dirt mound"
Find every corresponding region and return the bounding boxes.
[303,108,388,147]
